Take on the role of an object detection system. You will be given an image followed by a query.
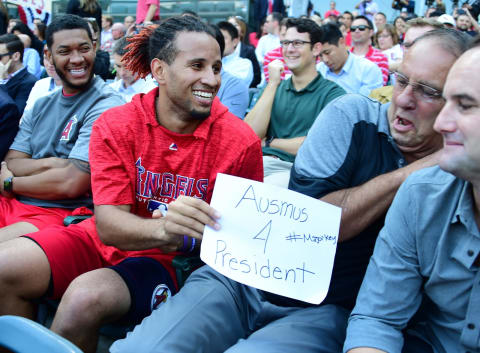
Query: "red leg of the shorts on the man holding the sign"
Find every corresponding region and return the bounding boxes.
[25,220,123,299]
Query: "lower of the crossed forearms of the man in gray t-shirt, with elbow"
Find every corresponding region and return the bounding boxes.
[13,159,90,200]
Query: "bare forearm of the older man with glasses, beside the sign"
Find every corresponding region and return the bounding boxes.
[321,152,439,241]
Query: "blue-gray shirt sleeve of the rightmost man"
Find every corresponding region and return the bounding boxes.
[344,179,423,353]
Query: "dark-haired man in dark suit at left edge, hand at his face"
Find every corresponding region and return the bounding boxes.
[0,34,37,115]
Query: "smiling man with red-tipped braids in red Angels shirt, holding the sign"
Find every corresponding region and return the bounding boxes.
[0,16,263,352]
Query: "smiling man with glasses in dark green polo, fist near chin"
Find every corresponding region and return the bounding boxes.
[245,19,345,188]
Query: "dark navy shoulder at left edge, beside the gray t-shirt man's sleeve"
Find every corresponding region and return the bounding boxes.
[0,89,20,161]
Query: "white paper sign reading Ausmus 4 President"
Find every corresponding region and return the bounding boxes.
[200,174,341,304]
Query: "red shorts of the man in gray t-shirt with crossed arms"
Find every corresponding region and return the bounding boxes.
[0,195,84,229]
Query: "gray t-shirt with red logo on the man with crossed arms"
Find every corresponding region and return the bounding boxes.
[10,77,125,209]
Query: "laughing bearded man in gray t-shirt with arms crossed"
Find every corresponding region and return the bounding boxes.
[0,15,124,242]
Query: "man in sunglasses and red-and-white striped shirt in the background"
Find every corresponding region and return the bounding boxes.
[350,16,389,85]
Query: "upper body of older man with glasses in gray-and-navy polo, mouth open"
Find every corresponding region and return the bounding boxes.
[288,29,467,352]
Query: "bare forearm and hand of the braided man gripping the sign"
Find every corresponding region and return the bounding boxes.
[95,196,219,252]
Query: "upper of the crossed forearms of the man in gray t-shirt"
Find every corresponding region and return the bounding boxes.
[5,150,68,176]
